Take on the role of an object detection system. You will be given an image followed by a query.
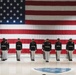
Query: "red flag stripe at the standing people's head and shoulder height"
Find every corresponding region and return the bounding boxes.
[0,38,76,44]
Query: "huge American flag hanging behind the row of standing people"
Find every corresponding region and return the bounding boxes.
[0,0,76,53]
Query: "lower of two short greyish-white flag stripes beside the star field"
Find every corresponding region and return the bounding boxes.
[25,15,76,20]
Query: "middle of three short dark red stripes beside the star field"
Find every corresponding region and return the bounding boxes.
[25,10,76,16]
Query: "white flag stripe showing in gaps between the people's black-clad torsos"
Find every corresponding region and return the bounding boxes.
[6,44,76,49]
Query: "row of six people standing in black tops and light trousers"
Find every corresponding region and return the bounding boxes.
[1,38,75,62]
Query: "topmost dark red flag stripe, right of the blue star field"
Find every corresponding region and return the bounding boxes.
[25,1,76,6]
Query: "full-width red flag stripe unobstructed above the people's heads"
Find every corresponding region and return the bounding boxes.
[0,29,76,35]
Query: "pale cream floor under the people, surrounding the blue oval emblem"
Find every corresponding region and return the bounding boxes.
[0,54,76,75]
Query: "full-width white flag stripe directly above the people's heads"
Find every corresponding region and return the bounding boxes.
[0,34,76,40]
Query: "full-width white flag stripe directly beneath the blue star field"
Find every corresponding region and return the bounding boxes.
[0,24,76,30]
